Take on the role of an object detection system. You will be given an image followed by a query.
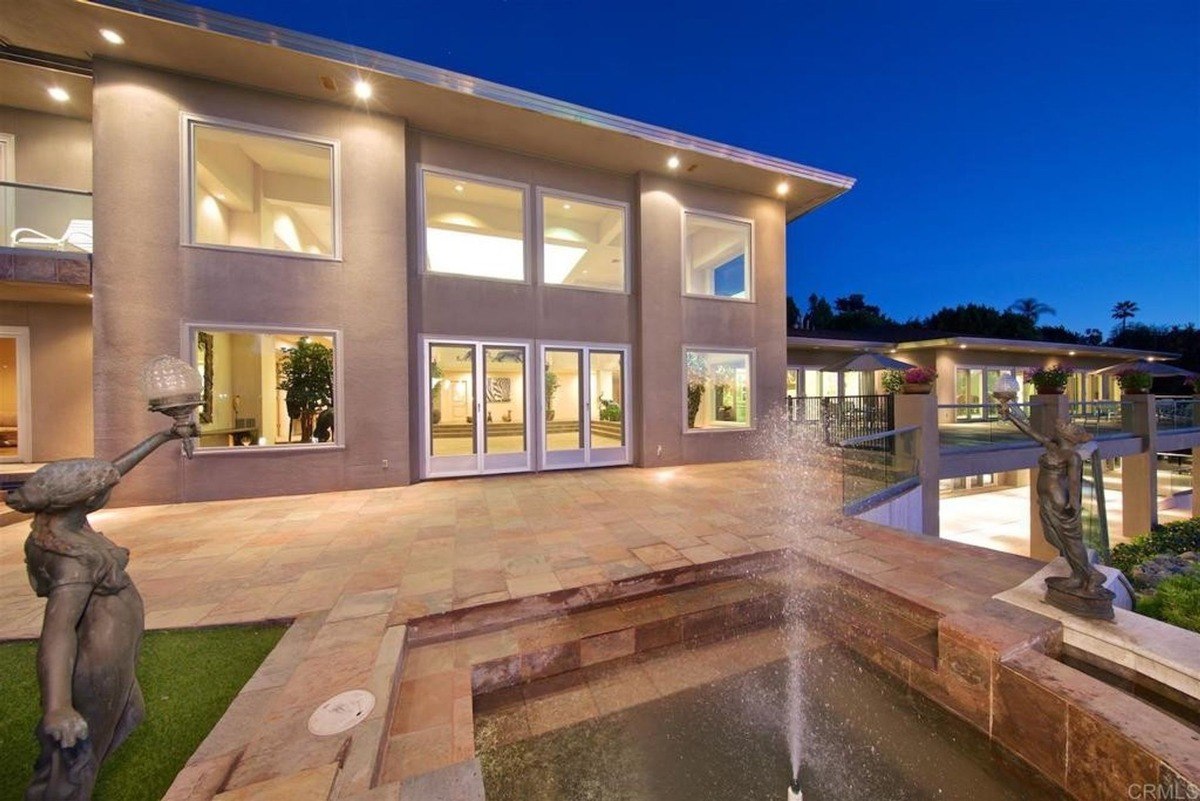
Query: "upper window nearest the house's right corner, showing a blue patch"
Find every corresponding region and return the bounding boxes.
[683,211,754,300]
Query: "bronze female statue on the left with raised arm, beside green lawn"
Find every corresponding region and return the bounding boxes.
[5,421,197,801]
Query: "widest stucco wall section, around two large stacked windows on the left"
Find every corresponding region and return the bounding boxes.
[92,60,409,504]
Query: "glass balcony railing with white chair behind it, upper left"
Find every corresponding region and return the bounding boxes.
[0,181,91,253]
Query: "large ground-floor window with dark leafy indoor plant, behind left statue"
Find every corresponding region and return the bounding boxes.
[192,327,340,448]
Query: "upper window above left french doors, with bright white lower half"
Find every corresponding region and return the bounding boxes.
[422,170,526,281]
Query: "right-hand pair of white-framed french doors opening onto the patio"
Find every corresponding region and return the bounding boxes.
[538,343,630,470]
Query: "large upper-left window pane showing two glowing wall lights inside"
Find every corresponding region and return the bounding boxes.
[187,120,338,258]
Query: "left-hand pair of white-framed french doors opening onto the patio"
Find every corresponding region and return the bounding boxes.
[421,337,533,478]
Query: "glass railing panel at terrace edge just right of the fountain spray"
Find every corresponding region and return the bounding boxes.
[839,426,920,514]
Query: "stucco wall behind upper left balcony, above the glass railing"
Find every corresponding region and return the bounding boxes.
[0,106,91,191]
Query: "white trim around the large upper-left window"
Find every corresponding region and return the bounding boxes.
[179,112,342,261]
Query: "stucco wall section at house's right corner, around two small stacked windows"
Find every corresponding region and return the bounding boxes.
[635,174,787,466]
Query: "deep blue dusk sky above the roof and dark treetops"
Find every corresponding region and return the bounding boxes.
[202,0,1200,331]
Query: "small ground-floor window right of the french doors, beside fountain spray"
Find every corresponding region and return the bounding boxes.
[684,348,754,430]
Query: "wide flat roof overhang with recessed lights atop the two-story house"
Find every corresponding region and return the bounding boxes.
[0,0,854,221]
